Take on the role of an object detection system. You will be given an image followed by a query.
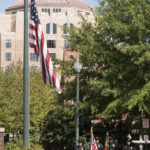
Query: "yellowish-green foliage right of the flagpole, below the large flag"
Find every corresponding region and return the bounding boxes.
[30,71,58,133]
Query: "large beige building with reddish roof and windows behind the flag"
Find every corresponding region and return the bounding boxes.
[0,0,94,70]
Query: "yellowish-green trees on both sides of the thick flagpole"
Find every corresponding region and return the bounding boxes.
[0,62,58,140]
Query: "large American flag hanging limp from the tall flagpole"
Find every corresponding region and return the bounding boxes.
[29,0,62,94]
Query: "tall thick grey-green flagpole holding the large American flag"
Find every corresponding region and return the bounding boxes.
[23,0,30,147]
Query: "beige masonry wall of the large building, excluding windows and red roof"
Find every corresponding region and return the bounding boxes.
[0,2,94,68]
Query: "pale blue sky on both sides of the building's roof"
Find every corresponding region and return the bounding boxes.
[0,0,98,14]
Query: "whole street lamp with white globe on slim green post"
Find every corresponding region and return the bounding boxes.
[73,58,82,146]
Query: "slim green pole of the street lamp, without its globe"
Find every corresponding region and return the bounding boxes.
[76,72,79,146]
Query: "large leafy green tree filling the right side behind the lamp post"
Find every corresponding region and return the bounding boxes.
[58,0,150,143]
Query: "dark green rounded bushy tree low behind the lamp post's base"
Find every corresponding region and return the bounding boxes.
[40,105,90,150]
